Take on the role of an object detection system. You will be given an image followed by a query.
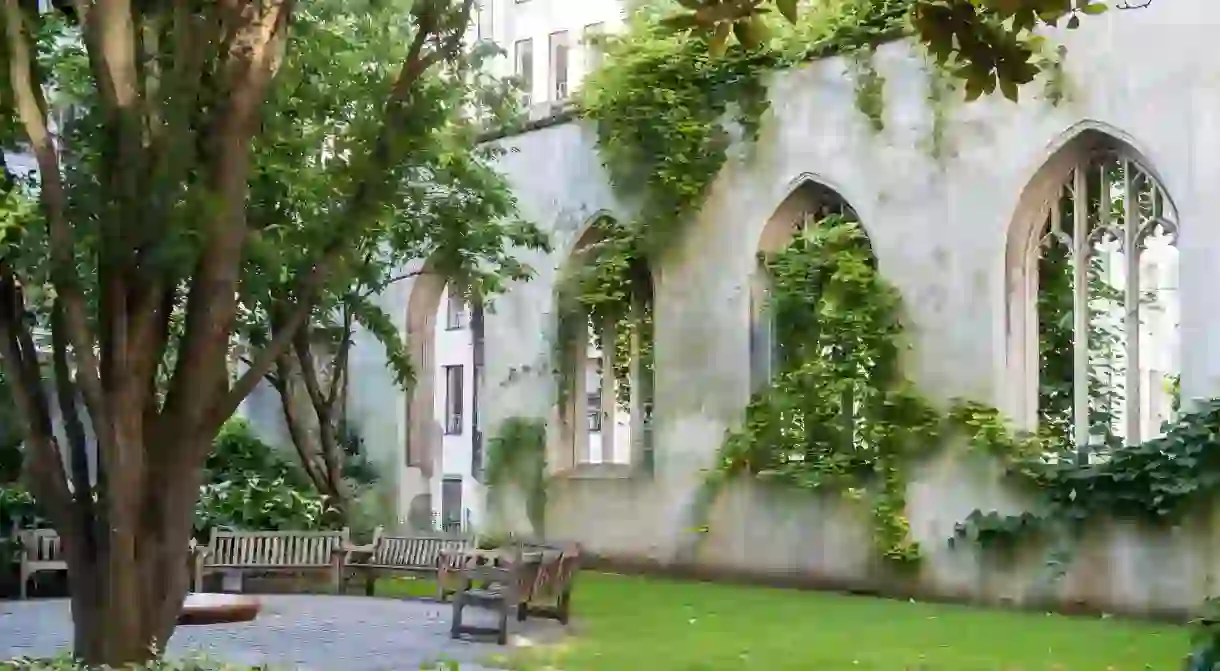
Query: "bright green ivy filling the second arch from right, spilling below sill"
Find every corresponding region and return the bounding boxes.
[720,216,941,560]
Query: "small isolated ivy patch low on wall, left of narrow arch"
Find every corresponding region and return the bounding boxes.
[484,417,547,534]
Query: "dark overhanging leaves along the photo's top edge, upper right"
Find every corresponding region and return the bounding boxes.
[667,0,1117,100]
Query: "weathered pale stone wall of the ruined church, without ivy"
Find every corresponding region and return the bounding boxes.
[334,0,1220,610]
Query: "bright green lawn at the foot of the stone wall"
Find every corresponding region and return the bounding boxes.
[377,572,1190,671]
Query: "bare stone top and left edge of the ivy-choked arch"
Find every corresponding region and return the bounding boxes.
[750,181,860,392]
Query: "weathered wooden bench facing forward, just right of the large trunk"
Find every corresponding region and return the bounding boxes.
[194,527,353,592]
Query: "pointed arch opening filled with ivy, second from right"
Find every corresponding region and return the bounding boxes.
[726,182,883,482]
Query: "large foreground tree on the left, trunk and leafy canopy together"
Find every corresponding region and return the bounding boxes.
[0,0,538,665]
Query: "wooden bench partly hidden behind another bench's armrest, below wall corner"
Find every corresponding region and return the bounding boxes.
[339,527,476,599]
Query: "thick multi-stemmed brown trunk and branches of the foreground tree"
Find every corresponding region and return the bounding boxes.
[0,0,490,665]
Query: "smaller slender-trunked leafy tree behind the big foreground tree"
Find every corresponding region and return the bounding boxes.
[240,1,545,527]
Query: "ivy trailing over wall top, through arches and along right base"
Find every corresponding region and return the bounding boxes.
[556,0,1200,575]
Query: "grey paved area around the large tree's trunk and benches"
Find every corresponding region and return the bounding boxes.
[0,594,558,671]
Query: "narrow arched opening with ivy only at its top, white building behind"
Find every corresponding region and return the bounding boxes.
[551,217,654,471]
